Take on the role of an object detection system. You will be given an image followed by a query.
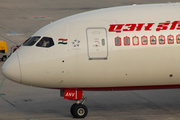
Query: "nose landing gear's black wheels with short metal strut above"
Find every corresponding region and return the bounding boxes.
[70,98,88,118]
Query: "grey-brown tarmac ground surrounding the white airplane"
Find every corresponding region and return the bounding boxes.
[0,0,180,120]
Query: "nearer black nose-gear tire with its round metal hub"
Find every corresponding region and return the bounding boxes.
[72,104,88,118]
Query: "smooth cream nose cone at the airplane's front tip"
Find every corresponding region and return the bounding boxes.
[2,51,21,83]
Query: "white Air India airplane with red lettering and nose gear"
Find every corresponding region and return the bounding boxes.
[2,3,180,118]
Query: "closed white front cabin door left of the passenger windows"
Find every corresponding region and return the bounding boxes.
[86,27,108,60]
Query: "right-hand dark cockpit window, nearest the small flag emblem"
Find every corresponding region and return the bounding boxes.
[36,37,54,47]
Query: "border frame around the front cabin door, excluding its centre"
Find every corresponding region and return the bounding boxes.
[86,27,108,60]
